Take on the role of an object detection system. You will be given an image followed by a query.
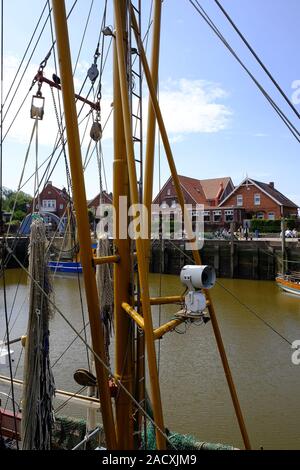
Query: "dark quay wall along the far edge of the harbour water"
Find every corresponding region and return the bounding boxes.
[2,237,300,280]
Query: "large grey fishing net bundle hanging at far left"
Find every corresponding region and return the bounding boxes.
[22,216,55,450]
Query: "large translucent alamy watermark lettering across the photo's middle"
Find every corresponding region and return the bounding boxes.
[96,196,204,250]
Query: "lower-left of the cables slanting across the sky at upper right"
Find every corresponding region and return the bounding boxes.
[188,0,300,143]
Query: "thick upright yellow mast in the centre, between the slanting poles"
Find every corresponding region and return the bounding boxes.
[113,0,134,450]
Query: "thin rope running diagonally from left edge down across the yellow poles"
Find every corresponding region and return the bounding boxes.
[6,250,176,450]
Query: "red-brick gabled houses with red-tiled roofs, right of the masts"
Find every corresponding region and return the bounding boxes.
[153,176,298,229]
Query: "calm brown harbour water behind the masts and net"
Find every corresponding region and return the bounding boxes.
[0,270,300,449]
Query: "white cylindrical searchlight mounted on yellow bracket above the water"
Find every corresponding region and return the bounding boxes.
[180,265,216,316]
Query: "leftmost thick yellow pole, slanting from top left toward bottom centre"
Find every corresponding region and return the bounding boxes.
[52,0,117,449]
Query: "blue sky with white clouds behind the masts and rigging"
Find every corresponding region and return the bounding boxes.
[3,0,300,205]
